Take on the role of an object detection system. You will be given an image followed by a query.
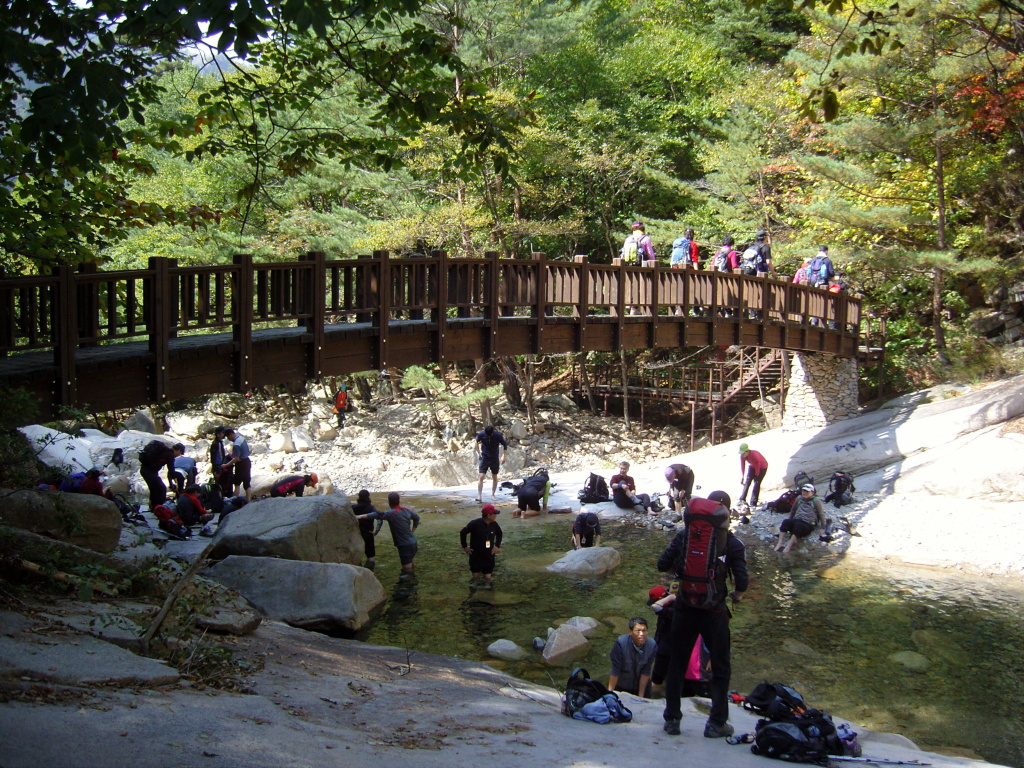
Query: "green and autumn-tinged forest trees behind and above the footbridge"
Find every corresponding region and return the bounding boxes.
[0,0,1024,391]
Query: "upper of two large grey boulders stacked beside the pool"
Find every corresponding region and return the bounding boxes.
[212,495,364,564]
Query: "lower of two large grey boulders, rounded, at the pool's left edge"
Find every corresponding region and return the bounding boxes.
[206,557,387,634]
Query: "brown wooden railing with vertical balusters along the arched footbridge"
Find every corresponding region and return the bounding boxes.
[0,252,861,362]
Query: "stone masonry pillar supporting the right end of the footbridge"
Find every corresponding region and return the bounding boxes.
[782,352,860,430]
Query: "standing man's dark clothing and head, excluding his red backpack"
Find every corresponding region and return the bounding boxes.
[657,490,750,738]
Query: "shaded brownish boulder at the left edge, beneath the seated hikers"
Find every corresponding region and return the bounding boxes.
[0,490,121,553]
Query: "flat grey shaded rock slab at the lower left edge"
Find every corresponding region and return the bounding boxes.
[0,633,180,687]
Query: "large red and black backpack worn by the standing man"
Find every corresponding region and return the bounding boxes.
[676,499,729,610]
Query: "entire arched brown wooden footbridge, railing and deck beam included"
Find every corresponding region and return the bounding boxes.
[0,252,861,416]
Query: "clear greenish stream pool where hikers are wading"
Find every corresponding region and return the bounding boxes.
[359,507,1024,766]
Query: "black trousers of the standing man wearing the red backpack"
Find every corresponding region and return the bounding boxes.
[665,607,732,725]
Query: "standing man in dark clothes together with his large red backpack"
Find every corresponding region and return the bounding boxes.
[657,490,750,738]
